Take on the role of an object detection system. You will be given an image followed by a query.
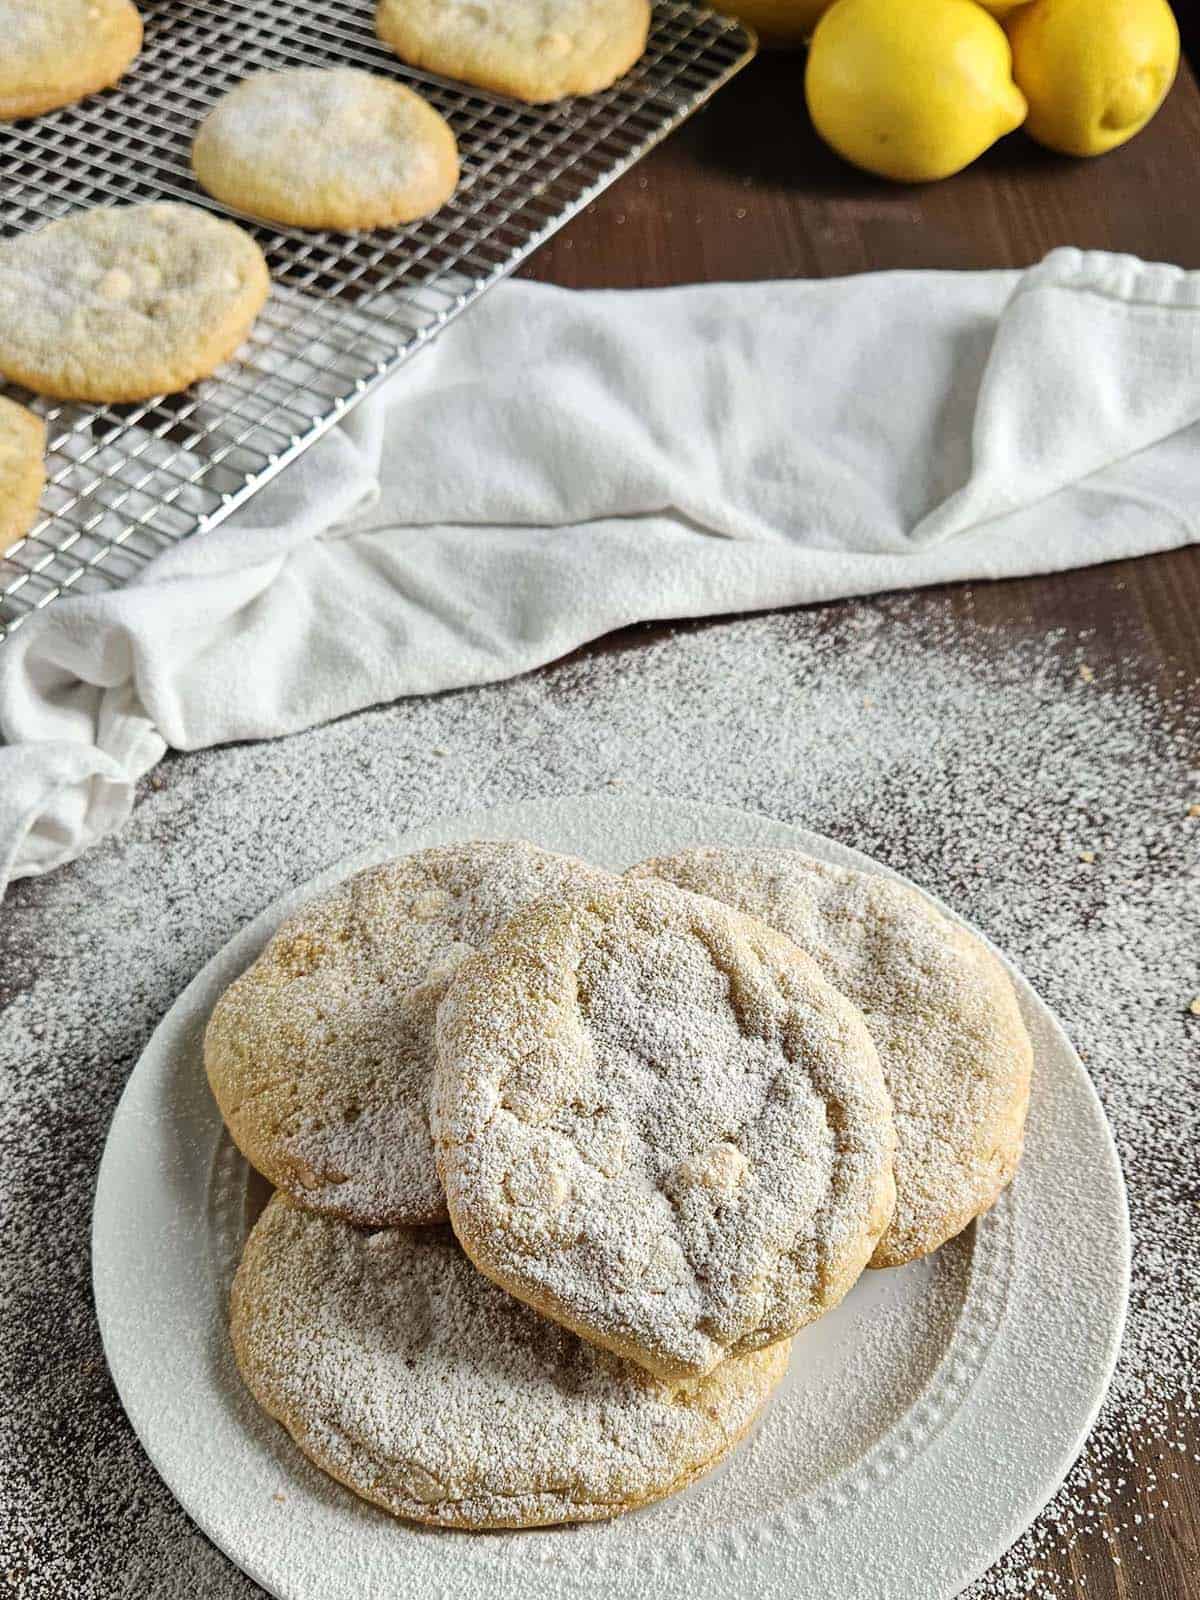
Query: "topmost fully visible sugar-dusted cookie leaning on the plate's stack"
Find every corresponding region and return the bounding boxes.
[432,883,894,1376]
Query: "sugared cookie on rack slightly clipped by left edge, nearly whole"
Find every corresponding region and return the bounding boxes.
[0,203,270,402]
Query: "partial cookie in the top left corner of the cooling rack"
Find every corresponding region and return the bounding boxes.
[0,0,142,122]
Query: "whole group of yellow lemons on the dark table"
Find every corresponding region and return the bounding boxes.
[718,0,1179,182]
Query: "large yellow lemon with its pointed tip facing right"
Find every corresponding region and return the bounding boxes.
[805,0,1026,182]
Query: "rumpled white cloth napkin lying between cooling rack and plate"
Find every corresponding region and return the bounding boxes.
[0,250,1200,886]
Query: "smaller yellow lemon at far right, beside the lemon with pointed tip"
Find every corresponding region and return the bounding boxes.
[1008,0,1179,155]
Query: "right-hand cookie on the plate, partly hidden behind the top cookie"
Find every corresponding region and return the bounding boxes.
[632,850,1032,1267]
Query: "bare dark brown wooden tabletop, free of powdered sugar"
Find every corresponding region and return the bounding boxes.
[523,37,1200,1600]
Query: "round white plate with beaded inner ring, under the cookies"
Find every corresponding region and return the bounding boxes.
[93,795,1130,1600]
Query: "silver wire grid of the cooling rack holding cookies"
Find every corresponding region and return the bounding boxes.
[0,0,754,640]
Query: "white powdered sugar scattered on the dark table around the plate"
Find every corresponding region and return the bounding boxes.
[0,595,1200,1600]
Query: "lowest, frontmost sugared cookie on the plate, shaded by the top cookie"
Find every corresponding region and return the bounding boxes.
[232,1195,800,1528]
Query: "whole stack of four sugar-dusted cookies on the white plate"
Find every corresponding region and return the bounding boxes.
[205,842,1032,1528]
